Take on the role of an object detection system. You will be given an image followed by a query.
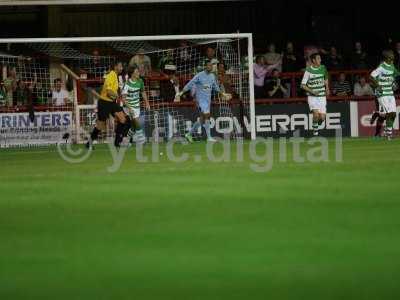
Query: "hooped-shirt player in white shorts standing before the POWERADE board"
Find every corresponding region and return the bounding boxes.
[301,53,329,135]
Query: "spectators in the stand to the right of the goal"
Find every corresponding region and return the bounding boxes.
[254,41,400,98]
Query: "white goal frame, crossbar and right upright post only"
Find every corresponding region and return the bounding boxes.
[0,33,256,140]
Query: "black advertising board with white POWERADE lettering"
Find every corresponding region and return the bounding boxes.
[155,103,351,137]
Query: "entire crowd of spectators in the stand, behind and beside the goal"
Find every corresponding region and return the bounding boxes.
[0,40,400,106]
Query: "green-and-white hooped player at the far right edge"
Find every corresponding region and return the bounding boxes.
[370,50,400,139]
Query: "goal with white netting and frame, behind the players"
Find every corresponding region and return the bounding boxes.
[0,34,255,147]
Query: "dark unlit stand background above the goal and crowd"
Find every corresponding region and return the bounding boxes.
[0,0,400,54]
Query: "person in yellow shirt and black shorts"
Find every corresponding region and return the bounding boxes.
[86,62,130,148]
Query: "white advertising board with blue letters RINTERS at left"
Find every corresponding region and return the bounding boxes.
[0,112,72,148]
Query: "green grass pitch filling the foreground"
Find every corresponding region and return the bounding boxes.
[0,139,400,300]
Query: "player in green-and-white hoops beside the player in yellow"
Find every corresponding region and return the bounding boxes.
[122,65,150,143]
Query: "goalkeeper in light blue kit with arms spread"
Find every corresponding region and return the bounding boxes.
[176,61,232,142]
